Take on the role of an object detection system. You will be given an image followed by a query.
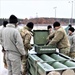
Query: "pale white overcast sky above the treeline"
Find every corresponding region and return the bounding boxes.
[0,0,75,19]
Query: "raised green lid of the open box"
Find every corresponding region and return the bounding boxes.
[33,30,49,45]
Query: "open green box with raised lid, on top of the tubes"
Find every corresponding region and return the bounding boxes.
[33,30,56,53]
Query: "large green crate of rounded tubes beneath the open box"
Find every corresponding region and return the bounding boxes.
[28,53,75,75]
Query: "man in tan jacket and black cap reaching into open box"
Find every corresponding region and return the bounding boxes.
[48,21,70,55]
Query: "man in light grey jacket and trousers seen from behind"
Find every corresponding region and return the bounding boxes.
[2,15,25,75]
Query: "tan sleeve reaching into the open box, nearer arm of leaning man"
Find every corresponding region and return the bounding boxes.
[49,31,63,45]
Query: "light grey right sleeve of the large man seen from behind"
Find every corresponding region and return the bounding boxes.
[15,31,26,55]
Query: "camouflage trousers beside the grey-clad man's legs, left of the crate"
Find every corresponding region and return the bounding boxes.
[22,51,28,75]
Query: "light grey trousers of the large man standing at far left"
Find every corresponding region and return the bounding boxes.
[6,52,21,75]
